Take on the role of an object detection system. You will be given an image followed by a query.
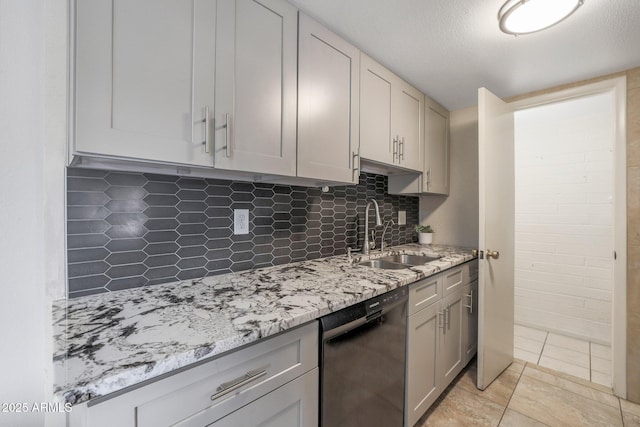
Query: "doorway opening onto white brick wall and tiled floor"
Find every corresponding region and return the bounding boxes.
[513,78,626,396]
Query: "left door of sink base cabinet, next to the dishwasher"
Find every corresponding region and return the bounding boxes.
[405,304,444,426]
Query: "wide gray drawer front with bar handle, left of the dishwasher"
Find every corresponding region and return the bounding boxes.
[136,322,318,427]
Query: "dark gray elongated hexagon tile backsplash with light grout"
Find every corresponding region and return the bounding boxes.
[67,168,418,298]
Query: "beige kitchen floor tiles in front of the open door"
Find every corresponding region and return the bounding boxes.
[416,359,640,427]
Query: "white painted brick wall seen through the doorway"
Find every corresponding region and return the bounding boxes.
[515,94,614,343]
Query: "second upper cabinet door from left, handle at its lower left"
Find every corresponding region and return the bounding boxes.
[214,0,298,176]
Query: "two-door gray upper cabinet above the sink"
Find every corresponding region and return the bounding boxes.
[360,54,424,172]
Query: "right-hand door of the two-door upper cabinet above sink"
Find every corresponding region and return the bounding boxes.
[391,79,424,171]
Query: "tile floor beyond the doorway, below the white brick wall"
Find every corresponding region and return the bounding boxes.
[513,325,612,387]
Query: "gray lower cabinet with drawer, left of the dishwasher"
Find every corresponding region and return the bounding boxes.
[69,322,319,427]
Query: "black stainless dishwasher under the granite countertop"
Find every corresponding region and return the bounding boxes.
[320,287,408,427]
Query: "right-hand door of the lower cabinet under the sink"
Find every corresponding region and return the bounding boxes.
[439,289,464,384]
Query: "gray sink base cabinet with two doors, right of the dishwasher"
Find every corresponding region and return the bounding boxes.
[405,261,477,427]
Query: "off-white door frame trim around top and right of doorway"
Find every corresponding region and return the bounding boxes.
[509,76,627,398]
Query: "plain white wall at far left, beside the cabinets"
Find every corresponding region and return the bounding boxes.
[0,0,67,427]
